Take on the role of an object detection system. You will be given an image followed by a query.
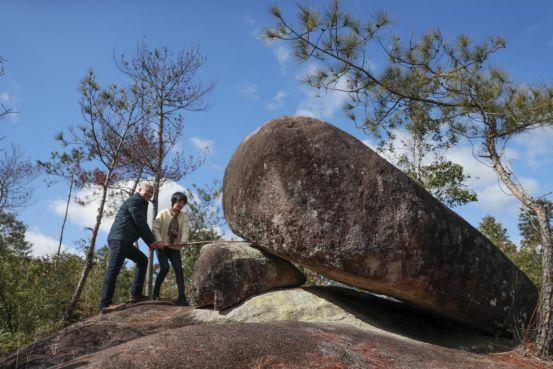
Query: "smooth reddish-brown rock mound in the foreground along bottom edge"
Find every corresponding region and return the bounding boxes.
[57,321,545,369]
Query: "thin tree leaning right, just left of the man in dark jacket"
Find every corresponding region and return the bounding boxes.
[60,71,144,320]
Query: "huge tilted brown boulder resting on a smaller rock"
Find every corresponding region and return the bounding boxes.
[223,117,537,330]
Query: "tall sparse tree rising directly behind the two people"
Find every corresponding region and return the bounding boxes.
[116,42,214,295]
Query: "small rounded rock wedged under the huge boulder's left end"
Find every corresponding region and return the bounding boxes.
[190,241,305,310]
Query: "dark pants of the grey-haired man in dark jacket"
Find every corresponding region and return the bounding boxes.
[100,240,148,308]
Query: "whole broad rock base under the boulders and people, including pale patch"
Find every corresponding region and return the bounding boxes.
[0,288,550,369]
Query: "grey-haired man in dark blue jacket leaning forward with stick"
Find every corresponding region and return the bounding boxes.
[100,183,165,312]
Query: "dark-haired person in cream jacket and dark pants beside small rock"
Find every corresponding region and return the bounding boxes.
[152,192,189,306]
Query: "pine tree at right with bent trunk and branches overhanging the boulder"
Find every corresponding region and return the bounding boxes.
[264,1,553,357]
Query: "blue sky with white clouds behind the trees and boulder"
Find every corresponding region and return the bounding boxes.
[0,0,553,255]
